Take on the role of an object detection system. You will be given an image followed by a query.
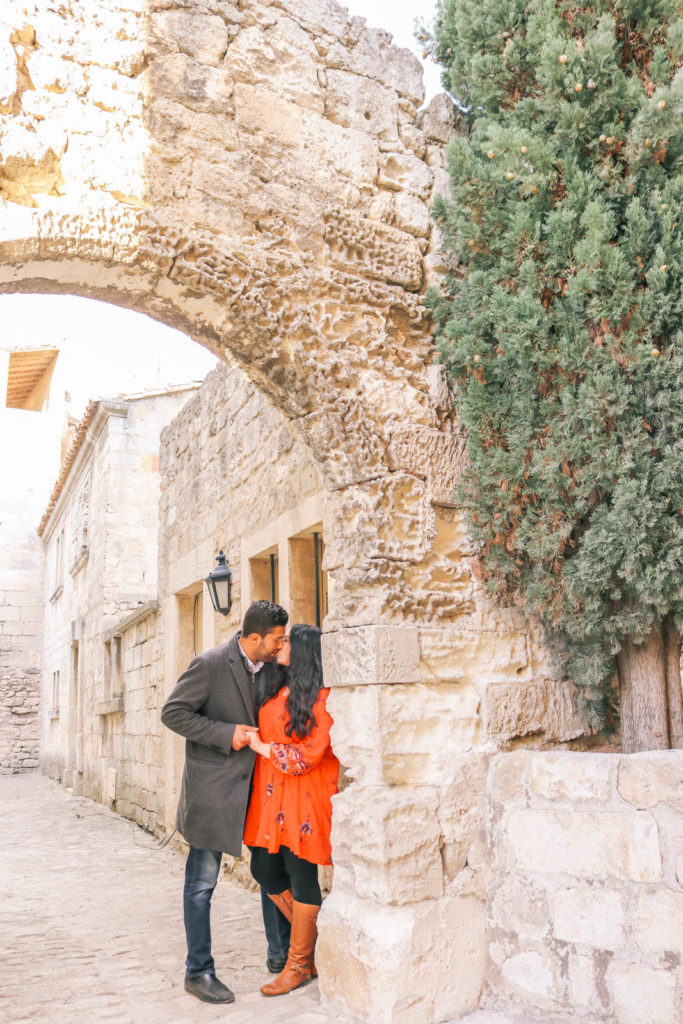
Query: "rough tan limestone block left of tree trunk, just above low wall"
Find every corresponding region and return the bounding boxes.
[483,666,584,742]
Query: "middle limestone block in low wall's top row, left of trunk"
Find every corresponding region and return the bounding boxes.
[530,753,618,803]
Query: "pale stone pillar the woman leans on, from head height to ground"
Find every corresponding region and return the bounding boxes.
[316,626,484,1024]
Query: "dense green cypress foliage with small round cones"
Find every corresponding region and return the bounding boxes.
[429,0,683,723]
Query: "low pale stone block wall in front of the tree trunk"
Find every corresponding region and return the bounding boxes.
[487,751,683,1024]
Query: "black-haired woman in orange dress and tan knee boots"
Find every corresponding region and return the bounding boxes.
[245,625,339,995]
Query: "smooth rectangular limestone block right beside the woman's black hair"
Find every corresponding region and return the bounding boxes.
[323,626,420,686]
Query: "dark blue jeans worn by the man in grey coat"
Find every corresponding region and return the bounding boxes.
[182,846,290,978]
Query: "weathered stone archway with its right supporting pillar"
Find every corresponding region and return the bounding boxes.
[0,0,561,1024]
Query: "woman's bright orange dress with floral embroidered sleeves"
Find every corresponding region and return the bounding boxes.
[245,687,339,864]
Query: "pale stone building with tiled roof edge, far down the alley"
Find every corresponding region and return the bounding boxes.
[39,387,198,806]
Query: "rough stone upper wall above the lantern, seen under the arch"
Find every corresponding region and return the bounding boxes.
[159,366,325,598]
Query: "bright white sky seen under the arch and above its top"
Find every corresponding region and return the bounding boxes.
[0,0,440,415]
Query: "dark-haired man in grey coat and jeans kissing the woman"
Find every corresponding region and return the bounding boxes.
[161,601,289,1002]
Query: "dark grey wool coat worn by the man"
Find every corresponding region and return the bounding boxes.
[161,633,269,857]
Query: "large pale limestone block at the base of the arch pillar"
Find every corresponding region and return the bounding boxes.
[316,890,485,1024]
